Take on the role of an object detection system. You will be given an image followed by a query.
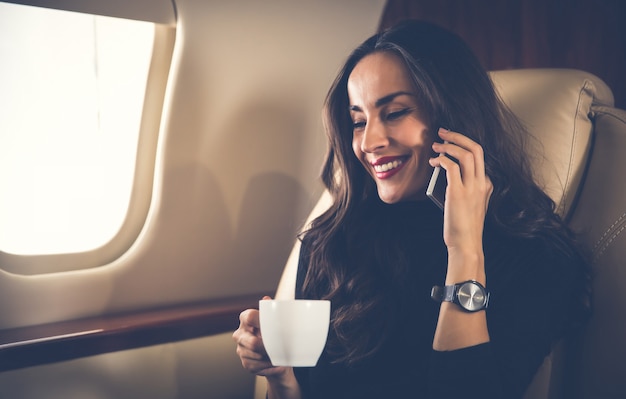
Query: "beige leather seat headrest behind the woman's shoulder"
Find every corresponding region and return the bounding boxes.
[490,69,613,217]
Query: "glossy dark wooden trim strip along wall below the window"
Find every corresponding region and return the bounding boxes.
[0,293,268,372]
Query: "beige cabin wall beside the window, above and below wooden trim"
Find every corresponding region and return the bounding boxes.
[0,0,384,399]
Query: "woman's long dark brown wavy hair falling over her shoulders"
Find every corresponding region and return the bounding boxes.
[303,21,588,363]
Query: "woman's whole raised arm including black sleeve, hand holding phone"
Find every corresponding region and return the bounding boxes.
[429,128,585,399]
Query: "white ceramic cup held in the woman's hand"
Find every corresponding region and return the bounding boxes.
[259,299,330,367]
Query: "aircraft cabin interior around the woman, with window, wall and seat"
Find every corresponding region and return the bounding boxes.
[0,0,626,399]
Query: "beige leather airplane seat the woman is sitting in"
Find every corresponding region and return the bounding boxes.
[257,69,626,399]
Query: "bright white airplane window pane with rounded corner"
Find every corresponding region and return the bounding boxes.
[0,3,155,255]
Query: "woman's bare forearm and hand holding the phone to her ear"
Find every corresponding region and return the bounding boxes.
[430,129,493,351]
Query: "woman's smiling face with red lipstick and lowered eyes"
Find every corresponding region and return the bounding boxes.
[348,53,434,204]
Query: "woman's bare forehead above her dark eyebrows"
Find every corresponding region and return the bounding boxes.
[348,52,414,104]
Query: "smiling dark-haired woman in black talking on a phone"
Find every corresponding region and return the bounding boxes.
[234,21,589,398]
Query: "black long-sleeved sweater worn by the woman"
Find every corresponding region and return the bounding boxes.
[295,200,585,399]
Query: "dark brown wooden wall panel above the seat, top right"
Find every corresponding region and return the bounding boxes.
[380,0,626,109]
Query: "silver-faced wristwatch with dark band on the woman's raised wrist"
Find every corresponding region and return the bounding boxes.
[430,280,489,312]
